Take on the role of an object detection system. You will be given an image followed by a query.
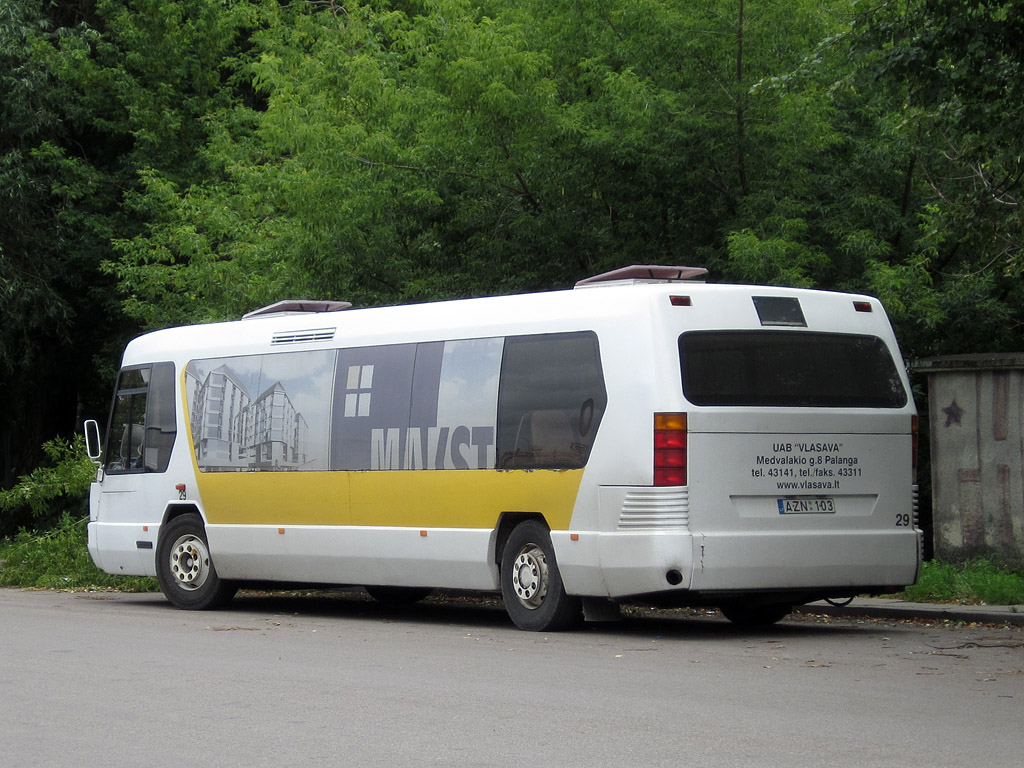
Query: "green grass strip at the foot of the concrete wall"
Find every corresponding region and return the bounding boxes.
[901,559,1024,605]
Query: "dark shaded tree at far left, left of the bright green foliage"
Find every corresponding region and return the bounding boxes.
[0,0,270,485]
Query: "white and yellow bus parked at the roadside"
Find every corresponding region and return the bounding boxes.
[86,266,922,631]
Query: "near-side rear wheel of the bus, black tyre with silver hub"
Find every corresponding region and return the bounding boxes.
[501,520,583,632]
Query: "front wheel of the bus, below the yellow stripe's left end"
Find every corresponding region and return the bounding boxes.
[157,513,238,610]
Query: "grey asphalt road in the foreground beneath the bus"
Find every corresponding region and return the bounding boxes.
[0,590,1024,768]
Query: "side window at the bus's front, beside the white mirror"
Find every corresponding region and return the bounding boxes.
[103,362,176,473]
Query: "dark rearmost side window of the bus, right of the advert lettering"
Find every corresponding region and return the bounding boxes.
[498,333,607,469]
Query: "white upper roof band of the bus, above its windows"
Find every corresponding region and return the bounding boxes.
[117,278,891,366]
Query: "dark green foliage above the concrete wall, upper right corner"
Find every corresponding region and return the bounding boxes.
[839,0,1024,352]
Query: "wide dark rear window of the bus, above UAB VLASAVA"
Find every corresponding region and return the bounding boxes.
[679,331,907,408]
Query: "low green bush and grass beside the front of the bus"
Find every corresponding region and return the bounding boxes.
[0,513,157,592]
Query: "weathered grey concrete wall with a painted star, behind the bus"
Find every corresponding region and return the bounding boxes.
[913,353,1024,561]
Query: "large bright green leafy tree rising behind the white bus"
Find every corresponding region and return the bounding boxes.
[110,0,856,325]
